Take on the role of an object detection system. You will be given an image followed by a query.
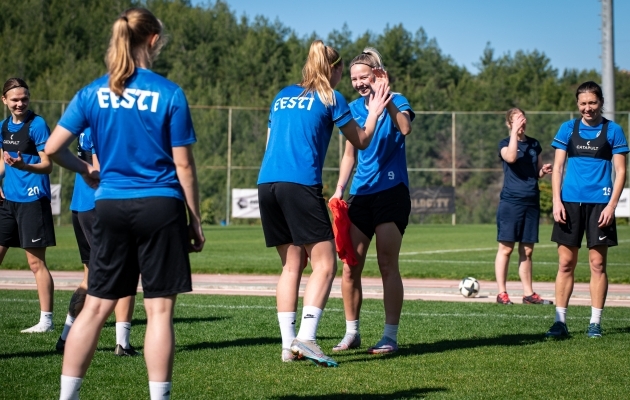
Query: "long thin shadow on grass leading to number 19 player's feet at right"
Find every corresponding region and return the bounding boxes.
[342,334,548,363]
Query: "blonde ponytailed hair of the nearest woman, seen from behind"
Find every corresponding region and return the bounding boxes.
[105,8,164,96]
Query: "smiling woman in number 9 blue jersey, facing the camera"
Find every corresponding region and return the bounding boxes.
[333,47,415,354]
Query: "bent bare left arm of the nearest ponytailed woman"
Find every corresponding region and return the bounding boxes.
[44,125,100,188]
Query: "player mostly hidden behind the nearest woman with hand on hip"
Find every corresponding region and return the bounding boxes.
[56,128,138,356]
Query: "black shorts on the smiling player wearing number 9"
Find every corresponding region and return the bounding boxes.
[348,183,411,239]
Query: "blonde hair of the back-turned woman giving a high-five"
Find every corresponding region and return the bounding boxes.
[299,40,343,107]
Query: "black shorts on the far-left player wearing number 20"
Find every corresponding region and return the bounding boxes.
[0,197,57,249]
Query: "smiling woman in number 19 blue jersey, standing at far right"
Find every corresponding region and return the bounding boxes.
[546,81,628,338]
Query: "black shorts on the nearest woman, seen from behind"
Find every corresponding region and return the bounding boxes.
[88,197,192,299]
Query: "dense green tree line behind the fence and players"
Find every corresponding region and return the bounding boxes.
[0,0,630,222]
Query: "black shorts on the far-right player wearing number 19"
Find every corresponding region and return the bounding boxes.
[551,201,617,249]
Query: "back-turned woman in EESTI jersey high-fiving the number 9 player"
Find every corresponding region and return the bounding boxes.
[258,40,389,366]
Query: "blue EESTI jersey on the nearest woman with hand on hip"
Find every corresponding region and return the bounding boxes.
[59,68,196,200]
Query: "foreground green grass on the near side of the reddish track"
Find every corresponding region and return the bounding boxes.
[0,291,630,400]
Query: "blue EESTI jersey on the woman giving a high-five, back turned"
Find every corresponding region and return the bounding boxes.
[258,85,352,186]
